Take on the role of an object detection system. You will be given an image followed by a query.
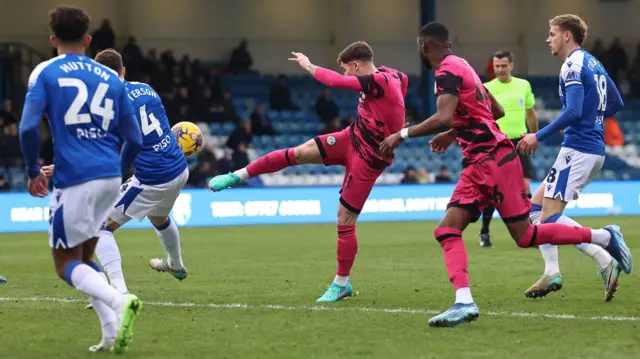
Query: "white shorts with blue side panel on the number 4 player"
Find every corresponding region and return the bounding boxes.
[109,168,189,225]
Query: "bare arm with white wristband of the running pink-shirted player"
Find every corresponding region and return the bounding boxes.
[380,93,458,157]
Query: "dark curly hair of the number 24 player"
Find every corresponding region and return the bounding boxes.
[49,6,91,42]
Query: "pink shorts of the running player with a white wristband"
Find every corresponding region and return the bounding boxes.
[448,146,531,222]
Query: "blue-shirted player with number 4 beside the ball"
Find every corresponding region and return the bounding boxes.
[43,49,189,300]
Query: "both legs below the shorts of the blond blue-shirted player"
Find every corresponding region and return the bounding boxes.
[525,184,621,301]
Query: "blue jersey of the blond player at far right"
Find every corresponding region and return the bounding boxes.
[560,49,612,155]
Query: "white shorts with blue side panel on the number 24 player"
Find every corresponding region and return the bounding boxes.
[49,177,122,249]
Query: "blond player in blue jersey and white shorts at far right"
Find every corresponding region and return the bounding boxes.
[518,15,630,301]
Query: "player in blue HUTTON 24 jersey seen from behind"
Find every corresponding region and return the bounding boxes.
[20,7,142,353]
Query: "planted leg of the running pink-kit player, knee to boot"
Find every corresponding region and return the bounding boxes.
[429,207,480,327]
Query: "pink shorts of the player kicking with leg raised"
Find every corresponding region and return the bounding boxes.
[314,128,384,214]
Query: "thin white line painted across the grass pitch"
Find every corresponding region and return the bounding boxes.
[0,297,640,322]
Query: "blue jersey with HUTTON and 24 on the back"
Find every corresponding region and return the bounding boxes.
[25,54,133,188]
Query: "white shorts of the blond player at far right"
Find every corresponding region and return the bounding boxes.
[543,147,604,202]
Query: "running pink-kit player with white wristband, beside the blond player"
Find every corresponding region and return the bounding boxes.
[381,22,631,327]
